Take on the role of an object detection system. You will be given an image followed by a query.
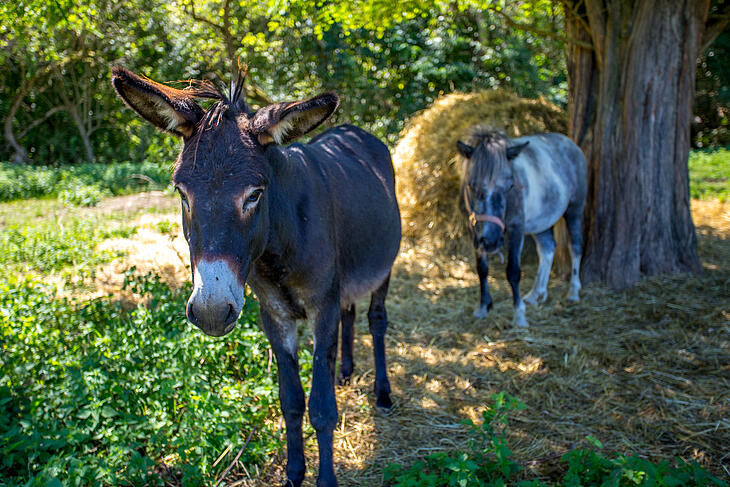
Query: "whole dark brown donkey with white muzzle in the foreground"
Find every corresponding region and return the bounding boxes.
[112,66,401,486]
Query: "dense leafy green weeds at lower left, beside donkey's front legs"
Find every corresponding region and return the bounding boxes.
[0,273,280,486]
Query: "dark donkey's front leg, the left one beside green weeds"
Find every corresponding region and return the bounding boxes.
[261,308,305,487]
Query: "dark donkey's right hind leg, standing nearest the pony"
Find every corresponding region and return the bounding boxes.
[368,274,393,411]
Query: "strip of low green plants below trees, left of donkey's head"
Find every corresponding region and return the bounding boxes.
[0,162,170,202]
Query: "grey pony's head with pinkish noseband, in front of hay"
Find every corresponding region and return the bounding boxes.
[457,132,527,253]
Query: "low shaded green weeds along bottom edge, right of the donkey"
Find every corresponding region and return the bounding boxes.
[383,392,727,487]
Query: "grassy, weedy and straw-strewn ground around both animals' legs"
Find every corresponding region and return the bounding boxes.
[0,150,730,487]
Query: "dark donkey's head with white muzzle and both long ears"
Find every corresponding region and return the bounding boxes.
[112,67,337,336]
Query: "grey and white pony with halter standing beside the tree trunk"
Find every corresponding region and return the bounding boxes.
[456,126,588,327]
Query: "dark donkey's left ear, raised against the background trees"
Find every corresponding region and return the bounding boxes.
[112,66,204,137]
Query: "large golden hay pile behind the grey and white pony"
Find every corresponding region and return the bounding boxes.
[393,90,568,250]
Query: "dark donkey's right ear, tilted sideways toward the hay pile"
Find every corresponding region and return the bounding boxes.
[251,93,339,145]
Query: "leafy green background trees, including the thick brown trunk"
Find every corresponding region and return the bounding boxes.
[0,0,730,288]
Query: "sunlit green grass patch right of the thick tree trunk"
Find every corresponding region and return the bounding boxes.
[689,148,730,201]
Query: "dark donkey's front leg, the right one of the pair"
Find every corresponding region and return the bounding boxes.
[309,300,340,487]
